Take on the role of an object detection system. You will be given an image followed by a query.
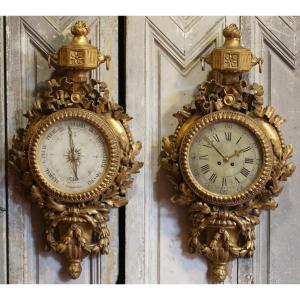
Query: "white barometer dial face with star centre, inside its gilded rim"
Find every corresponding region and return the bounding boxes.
[37,119,108,193]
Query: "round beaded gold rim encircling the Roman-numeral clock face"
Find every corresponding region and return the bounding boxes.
[179,111,273,206]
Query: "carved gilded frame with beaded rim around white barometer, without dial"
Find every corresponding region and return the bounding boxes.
[9,21,143,279]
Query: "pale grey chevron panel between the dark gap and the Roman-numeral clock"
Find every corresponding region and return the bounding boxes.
[126,17,238,283]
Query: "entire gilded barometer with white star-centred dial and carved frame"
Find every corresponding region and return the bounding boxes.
[9,21,142,279]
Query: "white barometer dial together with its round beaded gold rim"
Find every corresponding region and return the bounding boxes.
[29,109,120,202]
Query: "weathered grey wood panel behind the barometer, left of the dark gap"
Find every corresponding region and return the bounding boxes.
[5,16,118,283]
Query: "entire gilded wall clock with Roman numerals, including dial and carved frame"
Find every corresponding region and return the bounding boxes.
[161,25,295,283]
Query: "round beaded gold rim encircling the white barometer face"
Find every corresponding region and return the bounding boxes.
[28,108,121,203]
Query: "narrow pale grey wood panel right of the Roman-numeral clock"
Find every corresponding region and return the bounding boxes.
[239,17,300,283]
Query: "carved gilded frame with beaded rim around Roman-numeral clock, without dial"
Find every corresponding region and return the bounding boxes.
[161,25,295,283]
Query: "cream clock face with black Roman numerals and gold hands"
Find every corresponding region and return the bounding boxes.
[189,121,263,195]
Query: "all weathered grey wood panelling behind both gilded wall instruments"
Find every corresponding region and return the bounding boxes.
[0,16,300,283]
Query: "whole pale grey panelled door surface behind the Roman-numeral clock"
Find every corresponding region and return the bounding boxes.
[126,16,300,283]
